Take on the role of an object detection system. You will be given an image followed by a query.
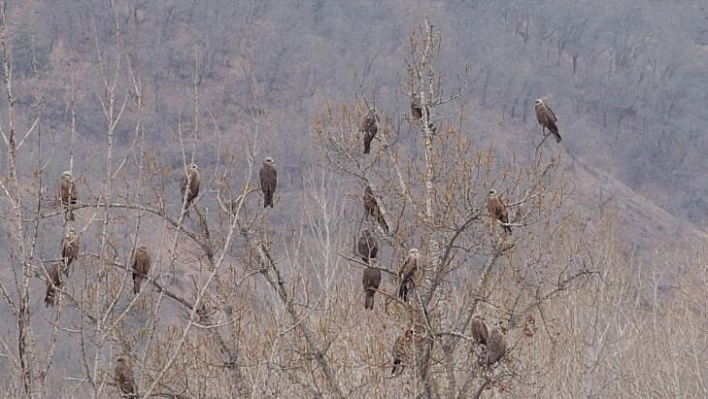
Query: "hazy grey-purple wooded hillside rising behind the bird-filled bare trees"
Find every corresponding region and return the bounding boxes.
[9,0,708,230]
